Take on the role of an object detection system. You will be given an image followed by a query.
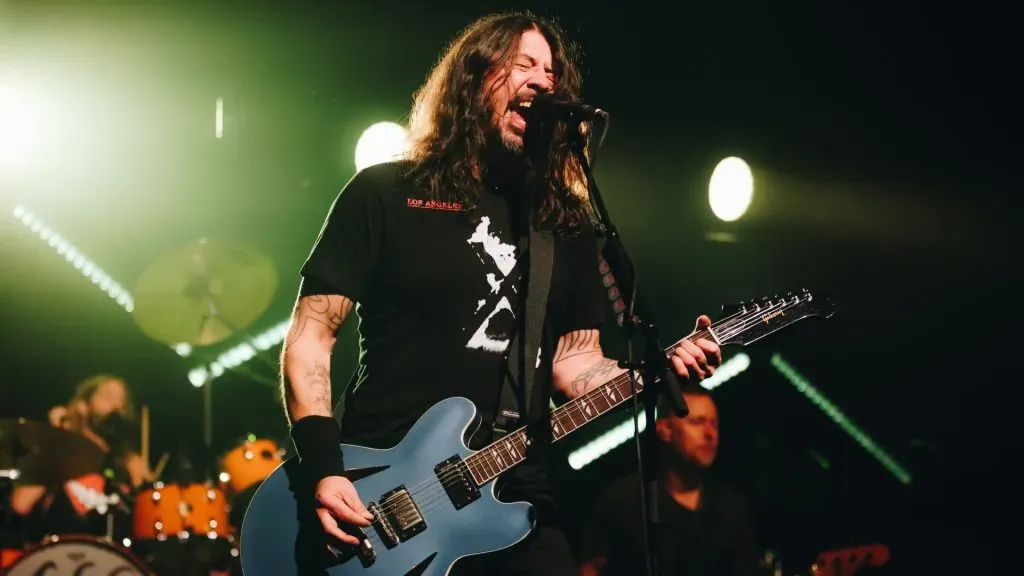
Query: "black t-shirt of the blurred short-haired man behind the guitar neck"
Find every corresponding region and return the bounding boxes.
[582,475,758,576]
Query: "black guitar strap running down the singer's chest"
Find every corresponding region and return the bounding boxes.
[492,227,555,441]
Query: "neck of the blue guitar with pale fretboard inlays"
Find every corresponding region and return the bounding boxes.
[466,318,729,486]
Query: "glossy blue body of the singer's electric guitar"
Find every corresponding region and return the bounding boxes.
[241,398,534,576]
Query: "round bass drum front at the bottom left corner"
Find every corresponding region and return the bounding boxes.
[5,535,155,576]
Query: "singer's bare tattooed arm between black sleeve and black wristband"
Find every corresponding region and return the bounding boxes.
[281,294,352,421]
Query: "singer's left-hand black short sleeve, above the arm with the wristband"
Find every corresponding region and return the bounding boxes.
[300,159,395,295]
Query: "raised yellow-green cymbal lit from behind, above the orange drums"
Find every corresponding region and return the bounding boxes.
[132,239,278,346]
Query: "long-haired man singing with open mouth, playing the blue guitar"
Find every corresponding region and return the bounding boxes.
[282,14,721,576]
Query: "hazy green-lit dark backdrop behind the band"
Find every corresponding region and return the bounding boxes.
[0,0,1007,573]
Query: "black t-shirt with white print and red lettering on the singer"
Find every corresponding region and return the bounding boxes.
[301,162,605,500]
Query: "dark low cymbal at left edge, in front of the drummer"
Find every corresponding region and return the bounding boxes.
[0,418,105,485]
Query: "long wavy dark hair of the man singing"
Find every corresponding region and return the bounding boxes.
[406,12,589,232]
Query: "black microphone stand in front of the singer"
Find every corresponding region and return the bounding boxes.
[566,113,689,576]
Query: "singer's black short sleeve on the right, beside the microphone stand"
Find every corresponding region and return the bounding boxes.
[554,222,607,336]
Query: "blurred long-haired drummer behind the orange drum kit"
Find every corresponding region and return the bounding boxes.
[10,374,153,534]
